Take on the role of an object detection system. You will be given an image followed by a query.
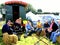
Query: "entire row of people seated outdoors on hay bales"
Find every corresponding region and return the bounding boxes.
[2,18,60,43]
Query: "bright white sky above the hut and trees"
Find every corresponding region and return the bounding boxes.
[0,0,60,12]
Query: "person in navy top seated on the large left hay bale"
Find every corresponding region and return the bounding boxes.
[2,20,13,34]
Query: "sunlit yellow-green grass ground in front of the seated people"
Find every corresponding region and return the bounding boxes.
[0,22,60,45]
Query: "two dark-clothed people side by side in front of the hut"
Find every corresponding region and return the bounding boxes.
[2,18,23,40]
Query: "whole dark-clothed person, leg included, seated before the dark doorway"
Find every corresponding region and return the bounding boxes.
[14,18,22,41]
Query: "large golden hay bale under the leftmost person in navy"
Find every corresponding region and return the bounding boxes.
[2,33,18,45]
